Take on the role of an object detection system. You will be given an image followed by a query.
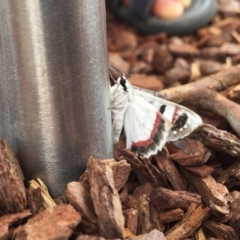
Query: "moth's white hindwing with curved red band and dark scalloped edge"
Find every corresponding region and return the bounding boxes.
[124,95,168,158]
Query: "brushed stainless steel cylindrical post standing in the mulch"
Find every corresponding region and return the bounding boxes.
[0,0,112,196]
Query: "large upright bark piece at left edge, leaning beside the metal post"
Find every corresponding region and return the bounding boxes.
[0,139,27,214]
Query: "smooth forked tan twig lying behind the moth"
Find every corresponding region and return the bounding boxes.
[159,65,240,136]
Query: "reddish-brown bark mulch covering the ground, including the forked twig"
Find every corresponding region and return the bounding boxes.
[0,0,240,240]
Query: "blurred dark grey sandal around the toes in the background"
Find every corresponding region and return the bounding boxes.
[106,0,217,35]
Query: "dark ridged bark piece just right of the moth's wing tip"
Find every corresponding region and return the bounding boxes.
[197,124,240,157]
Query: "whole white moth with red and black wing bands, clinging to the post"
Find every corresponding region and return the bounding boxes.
[110,74,202,158]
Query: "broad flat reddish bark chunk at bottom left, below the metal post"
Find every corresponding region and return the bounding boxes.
[14,204,81,240]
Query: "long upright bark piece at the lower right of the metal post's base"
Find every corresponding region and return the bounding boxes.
[87,157,124,238]
